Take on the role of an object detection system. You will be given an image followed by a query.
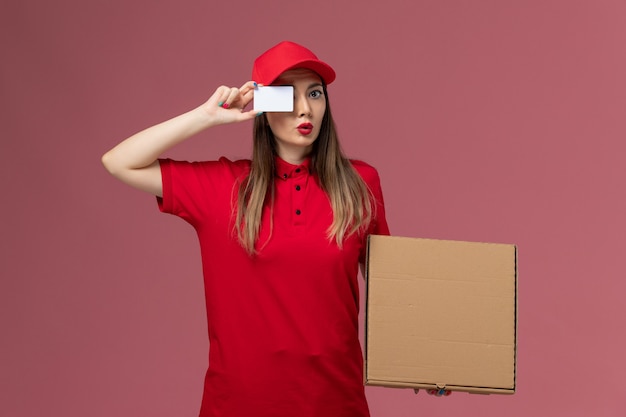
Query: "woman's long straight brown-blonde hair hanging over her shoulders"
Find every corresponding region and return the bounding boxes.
[235,85,375,255]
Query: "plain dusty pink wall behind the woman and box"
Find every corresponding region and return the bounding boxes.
[0,0,626,417]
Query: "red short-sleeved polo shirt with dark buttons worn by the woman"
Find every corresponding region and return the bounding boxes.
[158,158,389,417]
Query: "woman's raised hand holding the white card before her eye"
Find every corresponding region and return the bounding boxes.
[202,81,258,125]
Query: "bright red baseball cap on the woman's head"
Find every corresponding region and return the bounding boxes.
[252,41,335,85]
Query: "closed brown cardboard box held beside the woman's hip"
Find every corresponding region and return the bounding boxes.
[365,236,517,394]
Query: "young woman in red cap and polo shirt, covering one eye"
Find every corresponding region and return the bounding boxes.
[102,42,389,417]
